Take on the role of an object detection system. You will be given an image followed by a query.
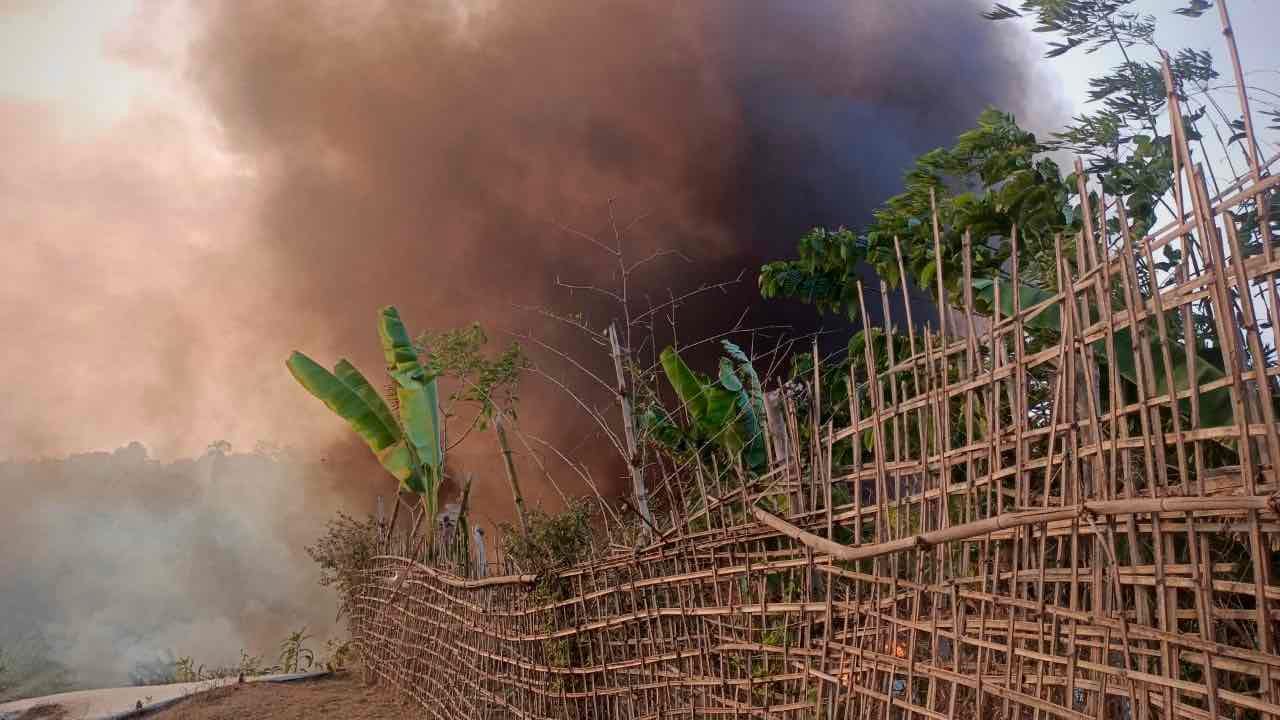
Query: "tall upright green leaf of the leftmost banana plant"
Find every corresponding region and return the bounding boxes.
[378,305,444,502]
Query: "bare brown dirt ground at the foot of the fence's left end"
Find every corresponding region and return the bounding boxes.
[138,671,404,720]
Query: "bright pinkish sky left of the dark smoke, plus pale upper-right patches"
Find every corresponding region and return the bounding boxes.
[0,0,1280,457]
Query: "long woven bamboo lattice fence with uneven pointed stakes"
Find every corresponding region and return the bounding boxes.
[352,47,1280,720]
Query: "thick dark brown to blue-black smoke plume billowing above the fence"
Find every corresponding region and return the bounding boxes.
[192,0,1049,504]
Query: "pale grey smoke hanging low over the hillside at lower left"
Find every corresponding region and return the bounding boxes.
[0,443,351,700]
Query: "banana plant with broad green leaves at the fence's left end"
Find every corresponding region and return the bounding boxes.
[285,306,444,520]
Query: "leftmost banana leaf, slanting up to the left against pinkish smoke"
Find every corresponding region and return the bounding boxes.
[285,351,415,483]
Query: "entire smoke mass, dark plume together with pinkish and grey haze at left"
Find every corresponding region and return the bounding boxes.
[0,0,1047,682]
